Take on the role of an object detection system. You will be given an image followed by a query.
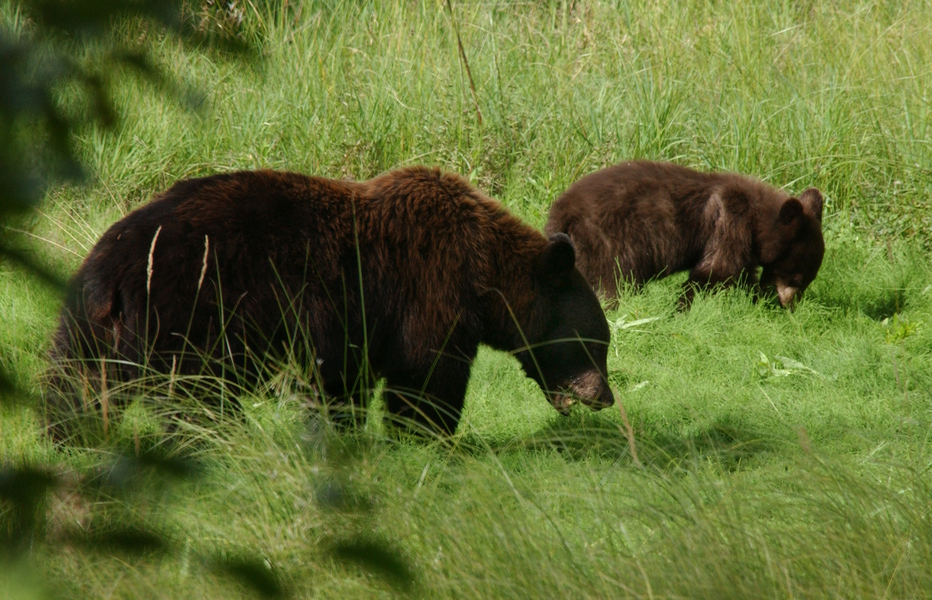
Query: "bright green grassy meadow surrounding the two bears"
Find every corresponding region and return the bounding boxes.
[0,0,932,599]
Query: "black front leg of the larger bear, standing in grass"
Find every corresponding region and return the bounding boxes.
[385,357,470,435]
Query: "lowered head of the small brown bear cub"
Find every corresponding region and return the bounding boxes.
[760,188,825,307]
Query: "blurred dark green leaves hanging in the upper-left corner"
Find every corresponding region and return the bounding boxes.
[0,0,188,399]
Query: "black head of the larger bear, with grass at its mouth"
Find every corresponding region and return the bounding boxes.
[516,233,615,415]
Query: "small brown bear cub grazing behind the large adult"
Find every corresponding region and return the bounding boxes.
[545,161,825,307]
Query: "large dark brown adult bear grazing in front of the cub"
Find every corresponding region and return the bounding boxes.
[49,167,614,434]
